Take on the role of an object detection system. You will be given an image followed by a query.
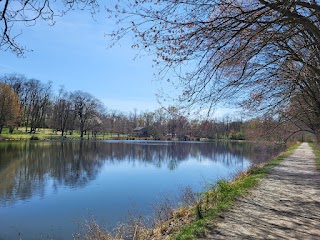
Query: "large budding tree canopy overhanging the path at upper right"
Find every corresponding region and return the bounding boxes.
[110,0,320,139]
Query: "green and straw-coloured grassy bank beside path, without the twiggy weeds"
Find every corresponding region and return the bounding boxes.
[148,143,300,240]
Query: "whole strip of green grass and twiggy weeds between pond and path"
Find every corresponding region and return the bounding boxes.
[74,142,300,240]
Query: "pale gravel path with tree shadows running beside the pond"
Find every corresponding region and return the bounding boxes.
[202,143,320,240]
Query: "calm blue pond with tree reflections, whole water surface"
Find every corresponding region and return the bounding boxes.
[0,141,281,240]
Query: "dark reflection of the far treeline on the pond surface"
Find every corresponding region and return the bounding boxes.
[0,141,279,206]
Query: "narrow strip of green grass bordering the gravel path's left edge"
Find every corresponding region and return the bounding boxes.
[171,144,300,240]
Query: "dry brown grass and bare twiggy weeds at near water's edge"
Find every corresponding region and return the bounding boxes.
[73,187,199,240]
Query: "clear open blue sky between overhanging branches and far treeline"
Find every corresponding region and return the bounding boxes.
[0,3,238,117]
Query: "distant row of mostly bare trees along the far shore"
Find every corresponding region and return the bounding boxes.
[0,74,308,141]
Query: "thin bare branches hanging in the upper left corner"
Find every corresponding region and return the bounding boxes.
[0,0,99,56]
